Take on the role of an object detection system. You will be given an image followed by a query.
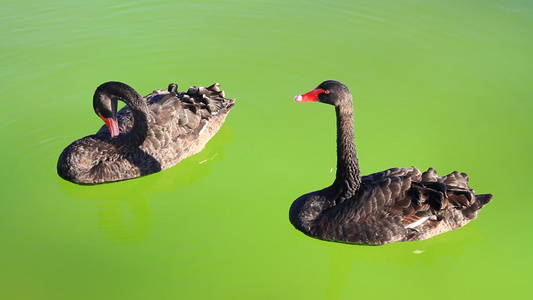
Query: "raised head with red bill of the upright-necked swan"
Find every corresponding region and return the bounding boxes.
[294,80,352,106]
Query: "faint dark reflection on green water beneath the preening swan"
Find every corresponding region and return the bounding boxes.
[57,126,233,244]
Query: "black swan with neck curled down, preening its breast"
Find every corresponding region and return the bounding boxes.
[57,81,235,184]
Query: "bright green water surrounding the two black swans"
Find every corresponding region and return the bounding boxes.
[0,0,533,300]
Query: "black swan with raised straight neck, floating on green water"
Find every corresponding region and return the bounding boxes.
[289,80,492,245]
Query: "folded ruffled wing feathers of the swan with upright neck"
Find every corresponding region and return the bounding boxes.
[360,167,492,229]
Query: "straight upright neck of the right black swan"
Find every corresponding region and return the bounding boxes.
[333,101,361,198]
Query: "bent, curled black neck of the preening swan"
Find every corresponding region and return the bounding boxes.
[95,82,148,148]
